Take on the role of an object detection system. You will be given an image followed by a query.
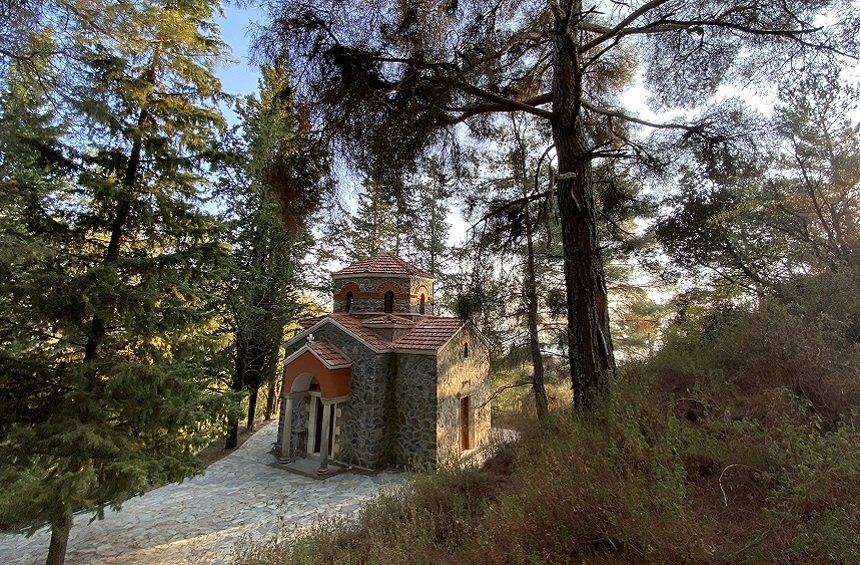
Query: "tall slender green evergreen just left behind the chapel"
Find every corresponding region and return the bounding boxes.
[214,63,326,449]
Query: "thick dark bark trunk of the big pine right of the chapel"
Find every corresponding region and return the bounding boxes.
[552,5,615,407]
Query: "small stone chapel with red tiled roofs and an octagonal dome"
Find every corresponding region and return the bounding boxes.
[275,254,490,475]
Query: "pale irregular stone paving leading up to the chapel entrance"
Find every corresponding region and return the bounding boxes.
[0,422,401,565]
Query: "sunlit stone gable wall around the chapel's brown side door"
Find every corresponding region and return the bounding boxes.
[436,325,490,466]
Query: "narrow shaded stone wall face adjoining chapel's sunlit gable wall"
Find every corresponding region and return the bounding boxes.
[390,353,436,468]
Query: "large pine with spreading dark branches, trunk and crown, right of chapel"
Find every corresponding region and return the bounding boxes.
[265,0,860,408]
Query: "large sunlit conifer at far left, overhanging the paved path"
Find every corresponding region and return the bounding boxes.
[0,0,235,563]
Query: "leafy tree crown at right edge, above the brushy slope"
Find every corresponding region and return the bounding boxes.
[657,67,860,296]
